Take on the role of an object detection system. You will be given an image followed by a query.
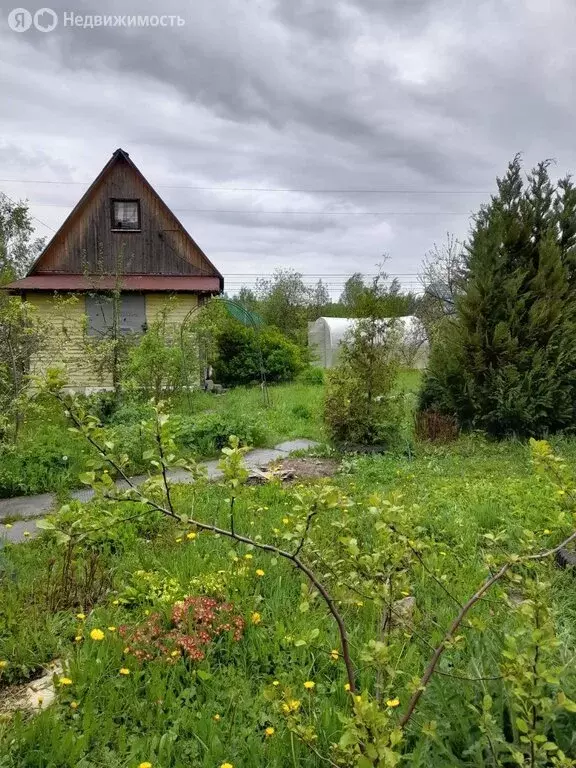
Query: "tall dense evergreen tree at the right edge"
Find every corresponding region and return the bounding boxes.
[421,156,576,437]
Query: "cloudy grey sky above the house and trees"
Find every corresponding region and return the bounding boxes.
[0,0,576,297]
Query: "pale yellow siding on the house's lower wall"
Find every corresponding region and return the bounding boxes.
[24,292,198,391]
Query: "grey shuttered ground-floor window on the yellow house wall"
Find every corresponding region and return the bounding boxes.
[85,293,146,338]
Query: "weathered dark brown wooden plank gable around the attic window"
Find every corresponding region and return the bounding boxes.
[30,155,219,276]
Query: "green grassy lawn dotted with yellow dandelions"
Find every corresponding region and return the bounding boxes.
[0,388,576,768]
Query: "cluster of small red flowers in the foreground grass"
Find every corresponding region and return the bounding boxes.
[118,597,244,663]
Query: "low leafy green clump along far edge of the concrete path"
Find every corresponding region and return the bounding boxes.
[176,412,266,455]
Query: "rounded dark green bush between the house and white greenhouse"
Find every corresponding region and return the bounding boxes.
[214,322,302,386]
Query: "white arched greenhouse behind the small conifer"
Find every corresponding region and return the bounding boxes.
[308,315,428,368]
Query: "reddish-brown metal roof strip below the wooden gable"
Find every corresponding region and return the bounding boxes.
[3,274,220,293]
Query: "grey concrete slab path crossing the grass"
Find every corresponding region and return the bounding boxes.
[0,439,319,547]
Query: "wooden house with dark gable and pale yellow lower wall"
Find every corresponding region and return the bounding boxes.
[6,149,224,391]
